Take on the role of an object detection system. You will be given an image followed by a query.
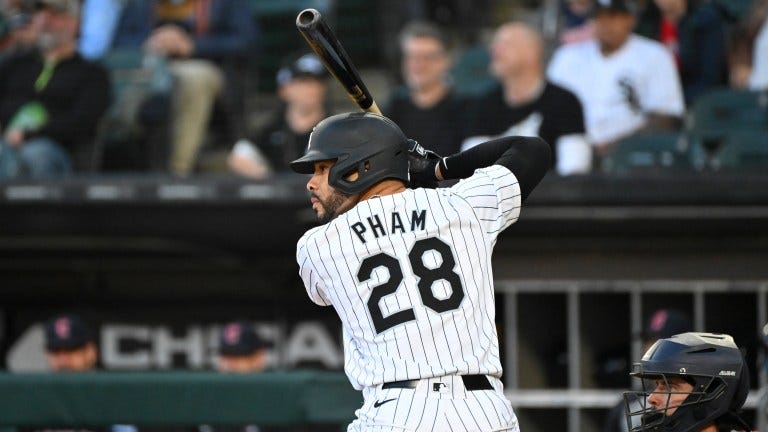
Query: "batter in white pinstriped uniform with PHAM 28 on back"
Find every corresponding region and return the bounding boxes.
[291,113,550,431]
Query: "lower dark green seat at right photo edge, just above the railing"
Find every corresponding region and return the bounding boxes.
[711,130,768,171]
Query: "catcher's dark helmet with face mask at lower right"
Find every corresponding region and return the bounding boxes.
[624,333,749,432]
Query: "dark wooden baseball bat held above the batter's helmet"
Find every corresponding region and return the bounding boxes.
[296,8,381,115]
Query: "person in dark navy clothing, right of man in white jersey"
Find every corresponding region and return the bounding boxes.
[637,0,727,105]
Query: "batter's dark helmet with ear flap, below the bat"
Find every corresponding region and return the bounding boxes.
[290,112,408,194]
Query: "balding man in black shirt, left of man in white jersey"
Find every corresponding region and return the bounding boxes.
[463,22,592,175]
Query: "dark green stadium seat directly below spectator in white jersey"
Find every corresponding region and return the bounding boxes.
[601,132,692,174]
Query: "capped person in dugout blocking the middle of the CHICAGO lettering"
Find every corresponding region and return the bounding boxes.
[216,321,267,373]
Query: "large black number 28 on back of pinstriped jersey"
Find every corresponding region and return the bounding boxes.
[357,237,464,333]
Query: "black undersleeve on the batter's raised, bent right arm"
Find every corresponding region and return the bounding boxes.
[435,136,552,199]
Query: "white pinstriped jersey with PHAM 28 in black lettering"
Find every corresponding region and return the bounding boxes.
[296,165,521,389]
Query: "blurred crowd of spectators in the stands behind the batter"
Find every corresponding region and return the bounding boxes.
[0,0,768,179]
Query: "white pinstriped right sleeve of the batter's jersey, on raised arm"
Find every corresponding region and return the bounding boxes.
[451,165,522,237]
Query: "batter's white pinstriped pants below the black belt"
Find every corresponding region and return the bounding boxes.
[347,376,520,432]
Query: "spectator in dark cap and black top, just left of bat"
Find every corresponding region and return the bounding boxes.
[228,54,330,178]
